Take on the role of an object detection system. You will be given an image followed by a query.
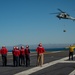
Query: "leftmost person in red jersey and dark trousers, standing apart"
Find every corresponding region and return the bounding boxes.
[1,46,8,66]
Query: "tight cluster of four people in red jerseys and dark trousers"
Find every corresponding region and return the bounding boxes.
[12,45,30,67]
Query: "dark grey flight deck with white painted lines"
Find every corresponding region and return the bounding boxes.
[0,51,75,75]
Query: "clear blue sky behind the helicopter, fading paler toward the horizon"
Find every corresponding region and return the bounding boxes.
[0,0,75,46]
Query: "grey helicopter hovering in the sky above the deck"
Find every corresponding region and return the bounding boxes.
[51,9,75,21]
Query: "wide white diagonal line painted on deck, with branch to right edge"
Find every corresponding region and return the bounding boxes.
[15,55,75,75]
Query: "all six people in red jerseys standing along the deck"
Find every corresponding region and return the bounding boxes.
[0,43,45,67]
